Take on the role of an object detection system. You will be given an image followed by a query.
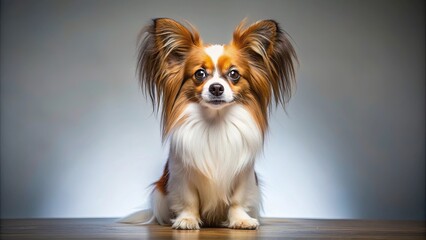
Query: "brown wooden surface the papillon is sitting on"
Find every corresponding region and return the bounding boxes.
[0,218,426,240]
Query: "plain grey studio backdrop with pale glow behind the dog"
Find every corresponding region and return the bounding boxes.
[0,0,425,220]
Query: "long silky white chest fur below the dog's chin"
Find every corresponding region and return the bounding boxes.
[170,104,263,188]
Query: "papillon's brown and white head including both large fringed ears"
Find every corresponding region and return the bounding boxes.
[138,18,297,134]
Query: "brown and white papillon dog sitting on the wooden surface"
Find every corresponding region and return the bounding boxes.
[122,18,297,229]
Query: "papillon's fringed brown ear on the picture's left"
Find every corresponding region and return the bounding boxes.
[137,18,202,109]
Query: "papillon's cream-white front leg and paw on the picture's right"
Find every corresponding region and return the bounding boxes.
[228,170,260,229]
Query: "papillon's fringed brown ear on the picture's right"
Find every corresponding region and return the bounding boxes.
[232,20,297,105]
